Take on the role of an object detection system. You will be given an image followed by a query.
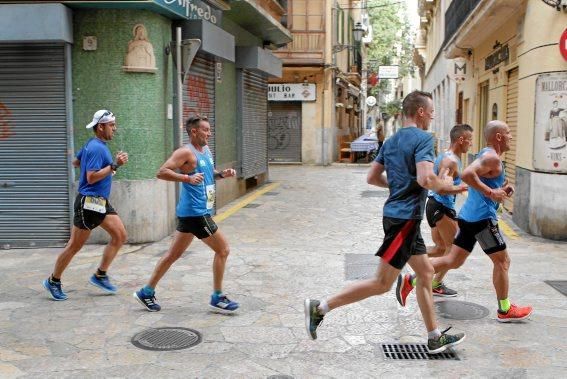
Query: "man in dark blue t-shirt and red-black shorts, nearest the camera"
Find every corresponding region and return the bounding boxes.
[304,91,466,353]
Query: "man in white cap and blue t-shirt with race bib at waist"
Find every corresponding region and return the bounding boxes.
[43,109,128,300]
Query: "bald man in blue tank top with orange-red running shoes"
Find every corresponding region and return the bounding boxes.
[400,120,533,322]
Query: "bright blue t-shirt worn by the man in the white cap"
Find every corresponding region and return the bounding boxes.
[77,138,112,199]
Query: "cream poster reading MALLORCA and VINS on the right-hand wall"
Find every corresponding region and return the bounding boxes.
[534,71,567,172]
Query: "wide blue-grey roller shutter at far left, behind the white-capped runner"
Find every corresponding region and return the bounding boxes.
[0,44,70,248]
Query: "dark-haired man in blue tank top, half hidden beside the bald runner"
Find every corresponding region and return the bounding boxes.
[426,124,473,297]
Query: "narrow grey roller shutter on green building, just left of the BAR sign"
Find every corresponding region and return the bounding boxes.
[238,70,268,179]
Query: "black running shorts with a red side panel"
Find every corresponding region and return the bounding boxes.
[376,217,427,270]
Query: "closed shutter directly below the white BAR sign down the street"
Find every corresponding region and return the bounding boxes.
[268,101,301,163]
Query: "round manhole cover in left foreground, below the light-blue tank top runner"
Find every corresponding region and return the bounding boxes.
[132,327,201,351]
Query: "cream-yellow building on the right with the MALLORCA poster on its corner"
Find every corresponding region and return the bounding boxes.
[422,0,567,239]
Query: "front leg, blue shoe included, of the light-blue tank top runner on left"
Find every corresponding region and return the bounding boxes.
[202,230,240,314]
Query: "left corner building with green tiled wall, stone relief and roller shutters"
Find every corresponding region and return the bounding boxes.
[0,0,291,247]
